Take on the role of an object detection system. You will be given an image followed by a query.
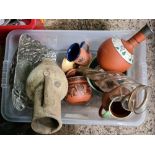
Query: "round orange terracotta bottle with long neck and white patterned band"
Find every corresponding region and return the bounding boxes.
[97,25,153,72]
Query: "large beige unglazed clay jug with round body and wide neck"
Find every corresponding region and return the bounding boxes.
[26,58,68,134]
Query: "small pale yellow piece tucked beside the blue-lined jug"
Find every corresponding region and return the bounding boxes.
[61,58,74,72]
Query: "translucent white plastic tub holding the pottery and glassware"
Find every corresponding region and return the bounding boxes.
[1,30,147,126]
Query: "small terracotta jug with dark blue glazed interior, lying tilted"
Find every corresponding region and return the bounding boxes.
[67,41,92,66]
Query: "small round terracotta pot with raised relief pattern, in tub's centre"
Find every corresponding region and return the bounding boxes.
[66,76,92,105]
